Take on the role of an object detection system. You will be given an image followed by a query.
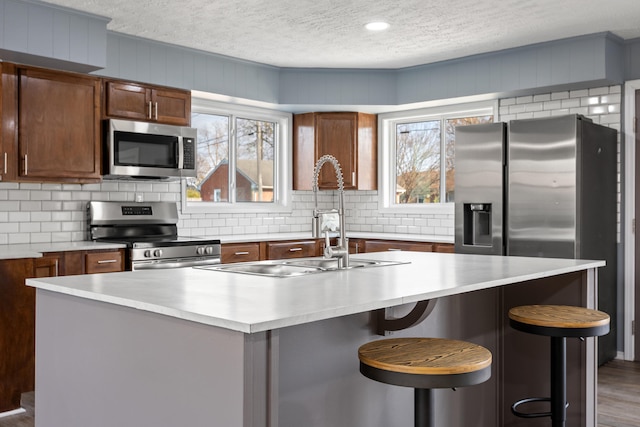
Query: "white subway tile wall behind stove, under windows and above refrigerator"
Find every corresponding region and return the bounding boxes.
[0,86,622,244]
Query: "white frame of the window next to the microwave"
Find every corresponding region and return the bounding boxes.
[181,94,293,213]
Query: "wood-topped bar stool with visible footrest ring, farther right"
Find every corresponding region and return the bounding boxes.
[509,305,609,427]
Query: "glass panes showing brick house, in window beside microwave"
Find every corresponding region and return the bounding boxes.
[186,112,276,203]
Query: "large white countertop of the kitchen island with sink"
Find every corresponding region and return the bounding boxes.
[27,252,605,333]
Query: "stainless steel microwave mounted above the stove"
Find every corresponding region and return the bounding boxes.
[103,119,197,179]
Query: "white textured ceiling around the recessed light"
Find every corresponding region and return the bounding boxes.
[38,0,640,68]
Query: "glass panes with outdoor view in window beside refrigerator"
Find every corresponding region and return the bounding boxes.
[395,115,493,204]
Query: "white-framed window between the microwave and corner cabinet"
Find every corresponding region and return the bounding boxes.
[183,97,291,212]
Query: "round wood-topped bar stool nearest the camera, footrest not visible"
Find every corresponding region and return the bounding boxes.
[358,338,491,427]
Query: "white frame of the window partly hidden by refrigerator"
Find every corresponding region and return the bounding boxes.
[378,100,498,215]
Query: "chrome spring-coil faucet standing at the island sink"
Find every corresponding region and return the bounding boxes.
[312,154,349,268]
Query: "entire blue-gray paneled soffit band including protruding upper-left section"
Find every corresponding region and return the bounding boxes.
[0,0,640,111]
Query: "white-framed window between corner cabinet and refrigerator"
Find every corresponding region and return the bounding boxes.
[379,102,495,212]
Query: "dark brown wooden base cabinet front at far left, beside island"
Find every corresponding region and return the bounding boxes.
[0,259,36,412]
